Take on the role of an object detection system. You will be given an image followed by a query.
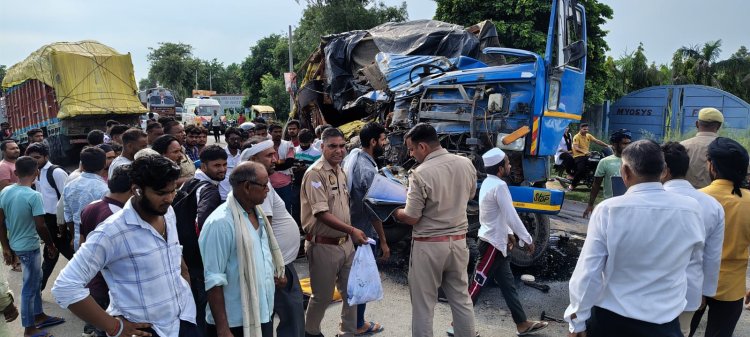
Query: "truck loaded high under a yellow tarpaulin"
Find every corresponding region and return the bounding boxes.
[2,41,148,164]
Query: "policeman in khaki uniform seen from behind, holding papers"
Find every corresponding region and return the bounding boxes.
[395,123,477,337]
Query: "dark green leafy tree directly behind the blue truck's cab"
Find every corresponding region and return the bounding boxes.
[435,0,613,104]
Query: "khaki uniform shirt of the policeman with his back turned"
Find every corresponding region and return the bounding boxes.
[404,149,477,237]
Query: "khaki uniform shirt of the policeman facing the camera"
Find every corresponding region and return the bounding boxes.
[300,158,351,238]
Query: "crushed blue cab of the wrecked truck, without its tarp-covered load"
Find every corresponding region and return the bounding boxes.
[388,0,586,265]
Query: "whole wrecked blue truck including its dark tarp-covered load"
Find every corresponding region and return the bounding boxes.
[295,0,587,266]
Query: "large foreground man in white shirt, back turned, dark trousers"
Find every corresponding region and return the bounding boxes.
[565,140,706,337]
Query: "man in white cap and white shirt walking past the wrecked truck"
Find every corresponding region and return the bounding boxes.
[469,148,548,336]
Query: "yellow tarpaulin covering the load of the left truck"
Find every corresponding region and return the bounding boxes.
[2,40,148,118]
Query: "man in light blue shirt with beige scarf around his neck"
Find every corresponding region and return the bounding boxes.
[198,162,286,337]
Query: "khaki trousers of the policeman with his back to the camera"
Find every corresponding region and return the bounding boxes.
[409,239,476,337]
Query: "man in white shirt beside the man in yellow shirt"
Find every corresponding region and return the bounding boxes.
[661,142,724,336]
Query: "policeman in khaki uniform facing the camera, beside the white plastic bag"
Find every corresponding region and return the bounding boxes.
[300,128,368,337]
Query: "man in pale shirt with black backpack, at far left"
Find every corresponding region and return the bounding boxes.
[26,143,73,290]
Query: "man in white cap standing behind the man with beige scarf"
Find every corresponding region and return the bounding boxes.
[240,137,305,336]
